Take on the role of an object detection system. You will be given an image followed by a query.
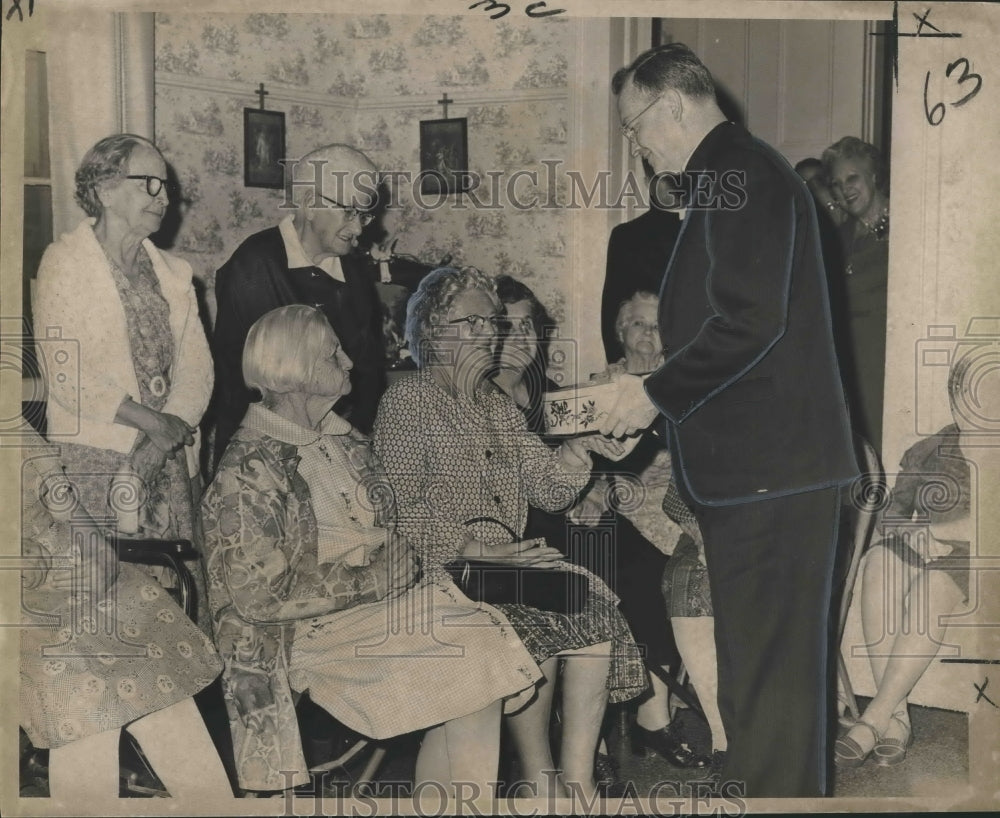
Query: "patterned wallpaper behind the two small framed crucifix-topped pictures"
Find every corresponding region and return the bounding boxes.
[156,14,573,320]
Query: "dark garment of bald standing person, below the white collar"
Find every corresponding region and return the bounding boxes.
[212,227,385,462]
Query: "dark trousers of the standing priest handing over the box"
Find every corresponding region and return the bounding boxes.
[693,488,840,798]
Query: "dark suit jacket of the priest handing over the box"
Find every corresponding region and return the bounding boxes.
[646,122,858,505]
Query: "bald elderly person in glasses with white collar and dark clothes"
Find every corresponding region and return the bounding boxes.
[212,145,385,463]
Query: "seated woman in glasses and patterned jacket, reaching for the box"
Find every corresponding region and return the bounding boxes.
[374,267,646,794]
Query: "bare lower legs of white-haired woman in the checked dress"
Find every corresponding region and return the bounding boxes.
[414,701,501,799]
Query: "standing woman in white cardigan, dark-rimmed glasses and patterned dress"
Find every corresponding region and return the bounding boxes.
[34,134,212,624]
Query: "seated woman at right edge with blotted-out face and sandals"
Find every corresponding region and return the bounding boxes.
[834,355,984,767]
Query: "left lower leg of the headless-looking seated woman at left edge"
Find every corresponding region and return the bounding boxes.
[49,728,121,806]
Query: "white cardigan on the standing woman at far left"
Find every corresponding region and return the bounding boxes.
[33,219,213,474]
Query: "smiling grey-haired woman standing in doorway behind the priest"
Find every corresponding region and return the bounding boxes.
[822,136,889,456]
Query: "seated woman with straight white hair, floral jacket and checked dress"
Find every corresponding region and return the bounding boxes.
[202,305,540,790]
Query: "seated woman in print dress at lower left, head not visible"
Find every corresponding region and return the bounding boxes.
[20,430,232,800]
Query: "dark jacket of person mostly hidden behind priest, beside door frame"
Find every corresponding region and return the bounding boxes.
[601,208,681,364]
